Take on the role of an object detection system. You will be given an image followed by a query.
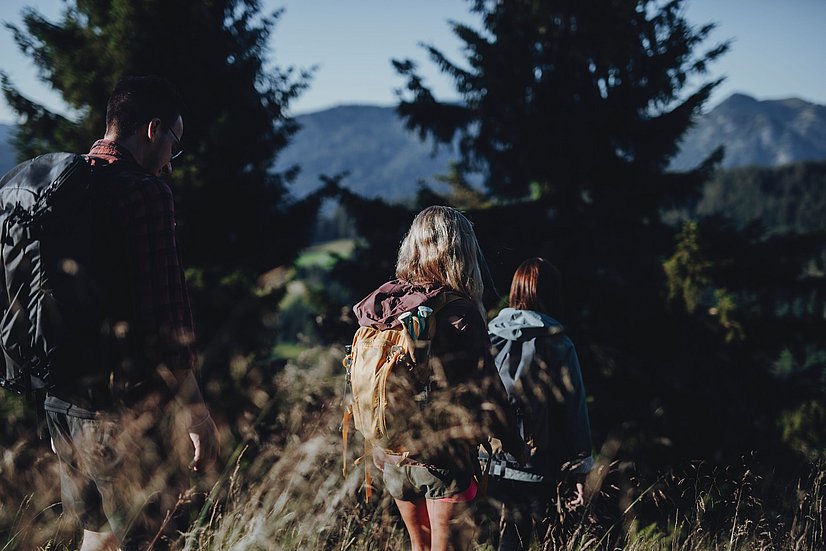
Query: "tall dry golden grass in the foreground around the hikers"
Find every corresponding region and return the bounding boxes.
[0,342,826,551]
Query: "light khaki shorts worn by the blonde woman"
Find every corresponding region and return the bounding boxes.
[382,462,476,502]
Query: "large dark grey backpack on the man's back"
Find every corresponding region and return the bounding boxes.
[0,153,104,397]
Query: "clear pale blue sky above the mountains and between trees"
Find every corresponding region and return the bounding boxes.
[0,0,826,123]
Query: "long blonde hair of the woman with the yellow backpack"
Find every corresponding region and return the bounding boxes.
[396,206,485,308]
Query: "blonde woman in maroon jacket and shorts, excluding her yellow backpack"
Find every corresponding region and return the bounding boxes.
[354,206,522,551]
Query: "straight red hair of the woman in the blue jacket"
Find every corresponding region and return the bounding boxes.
[509,257,562,318]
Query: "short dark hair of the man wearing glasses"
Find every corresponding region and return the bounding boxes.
[106,75,183,136]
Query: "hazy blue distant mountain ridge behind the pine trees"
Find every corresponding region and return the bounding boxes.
[0,94,826,201]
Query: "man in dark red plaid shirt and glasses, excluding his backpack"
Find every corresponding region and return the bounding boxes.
[45,77,218,551]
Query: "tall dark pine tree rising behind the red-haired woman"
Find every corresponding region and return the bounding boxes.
[394,0,728,324]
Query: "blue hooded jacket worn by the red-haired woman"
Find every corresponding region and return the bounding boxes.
[488,308,593,478]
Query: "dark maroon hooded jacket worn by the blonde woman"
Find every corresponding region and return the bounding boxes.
[353,280,522,468]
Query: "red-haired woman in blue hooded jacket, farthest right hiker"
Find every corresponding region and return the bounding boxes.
[488,258,593,551]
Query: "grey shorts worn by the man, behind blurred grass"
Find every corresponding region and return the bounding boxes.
[46,404,189,550]
